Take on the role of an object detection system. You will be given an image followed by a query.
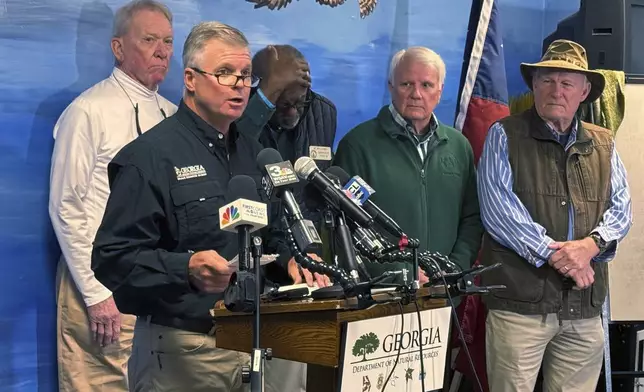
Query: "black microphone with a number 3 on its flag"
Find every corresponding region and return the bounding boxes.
[257,148,322,253]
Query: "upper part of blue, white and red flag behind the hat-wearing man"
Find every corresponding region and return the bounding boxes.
[455,0,510,162]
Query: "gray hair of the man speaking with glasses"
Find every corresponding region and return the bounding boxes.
[182,22,249,68]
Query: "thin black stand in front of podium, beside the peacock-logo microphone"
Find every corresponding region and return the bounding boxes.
[248,237,272,392]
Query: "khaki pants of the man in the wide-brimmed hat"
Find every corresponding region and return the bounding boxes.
[485,310,604,392]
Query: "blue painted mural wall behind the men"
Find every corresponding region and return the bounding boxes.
[0,0,561,392]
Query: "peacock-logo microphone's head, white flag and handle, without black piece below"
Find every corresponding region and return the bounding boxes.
[219,175,268,271]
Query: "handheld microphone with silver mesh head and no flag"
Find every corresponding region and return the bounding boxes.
[295,157,373,228]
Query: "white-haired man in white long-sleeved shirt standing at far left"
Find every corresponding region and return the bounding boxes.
[49,0,177,392]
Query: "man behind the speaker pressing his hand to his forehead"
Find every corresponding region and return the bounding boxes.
[237,45,337,170]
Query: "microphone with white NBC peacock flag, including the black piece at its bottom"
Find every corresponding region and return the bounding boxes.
[219,175,268,312]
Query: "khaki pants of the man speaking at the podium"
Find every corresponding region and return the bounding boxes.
[129,317,250,392]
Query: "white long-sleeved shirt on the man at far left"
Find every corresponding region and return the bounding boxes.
[49,68,177,306]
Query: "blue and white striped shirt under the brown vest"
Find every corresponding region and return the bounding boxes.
[478,123,633,267]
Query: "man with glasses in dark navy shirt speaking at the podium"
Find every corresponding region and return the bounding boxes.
[92,22,328,392]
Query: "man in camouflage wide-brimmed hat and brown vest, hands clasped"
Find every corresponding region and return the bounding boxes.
[478,40,632,392]
